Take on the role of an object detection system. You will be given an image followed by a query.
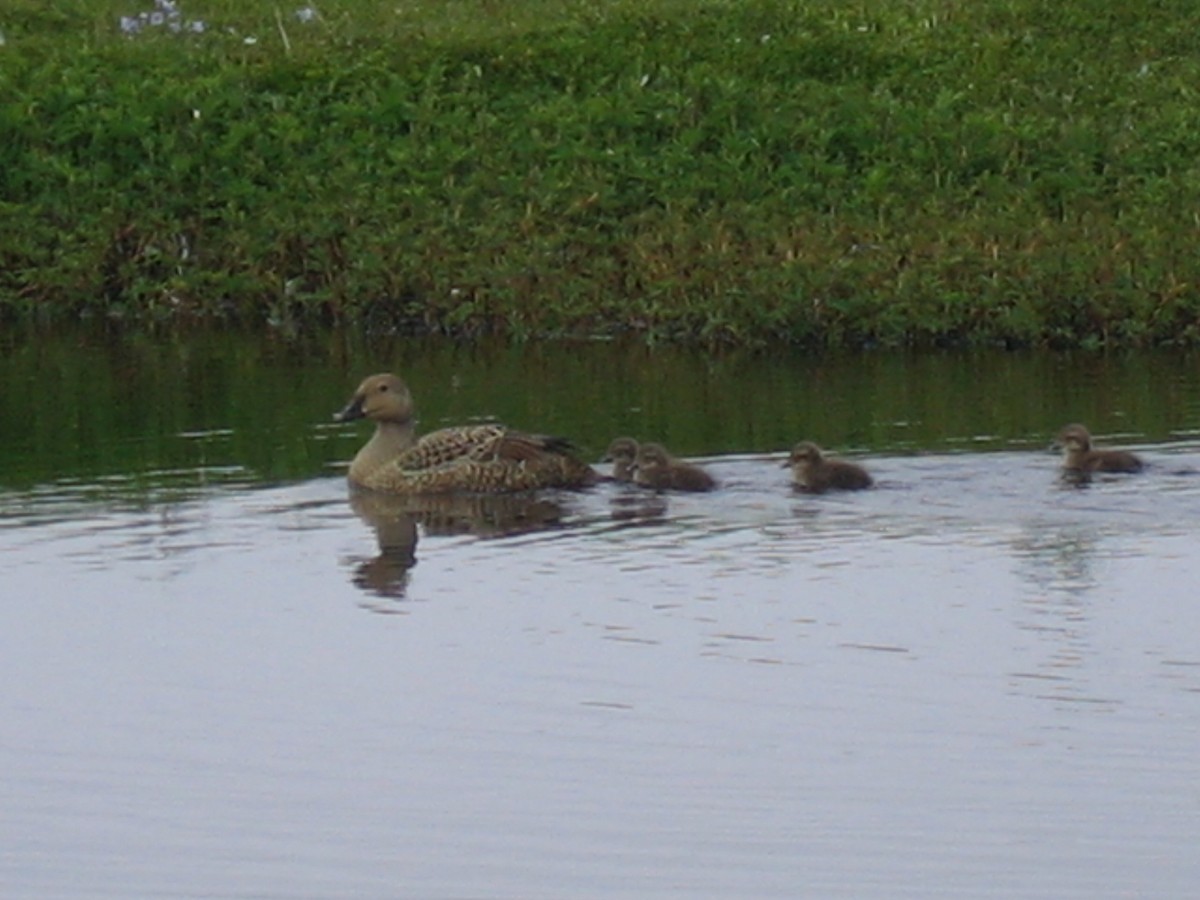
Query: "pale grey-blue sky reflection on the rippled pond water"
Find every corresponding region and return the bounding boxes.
[0,445,1200,898]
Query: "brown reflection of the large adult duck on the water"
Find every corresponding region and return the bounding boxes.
[349,490,564,600]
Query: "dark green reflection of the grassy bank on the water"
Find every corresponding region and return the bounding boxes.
[0,331,1200,488]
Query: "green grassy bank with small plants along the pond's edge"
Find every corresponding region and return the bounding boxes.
[7,0,1200,347]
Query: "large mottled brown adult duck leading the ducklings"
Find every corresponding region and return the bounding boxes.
[334,372,598,494]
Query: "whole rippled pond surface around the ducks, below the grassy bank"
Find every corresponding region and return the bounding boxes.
[0,335,1200,899]
